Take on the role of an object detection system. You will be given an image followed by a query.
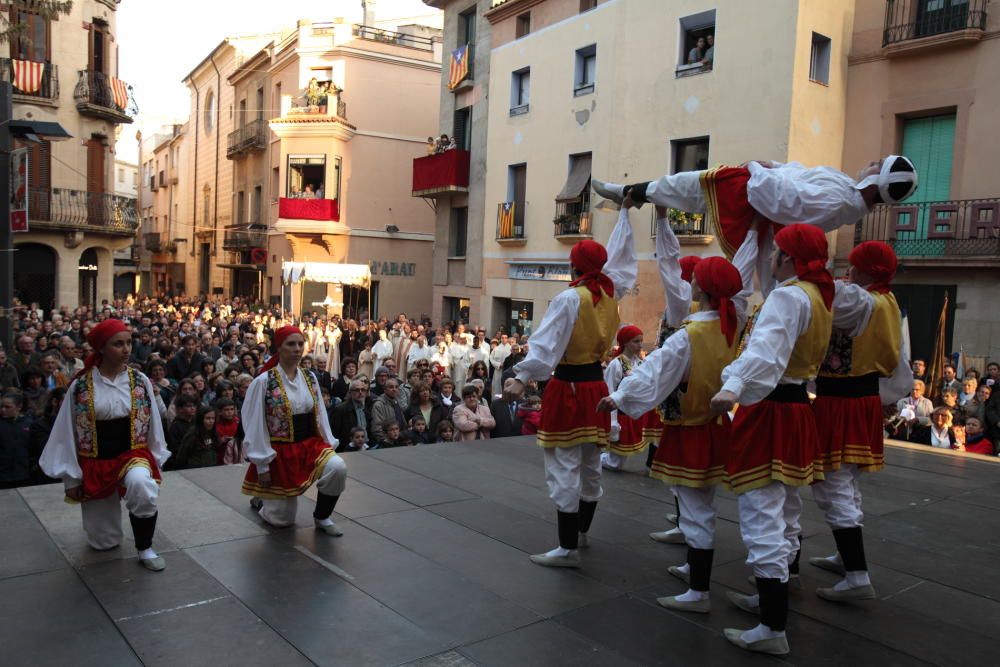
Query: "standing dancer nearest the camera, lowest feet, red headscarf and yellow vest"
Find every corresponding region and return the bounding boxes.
[712,225,834,654]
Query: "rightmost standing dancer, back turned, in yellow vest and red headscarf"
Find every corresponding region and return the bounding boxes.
[809,241,913,602]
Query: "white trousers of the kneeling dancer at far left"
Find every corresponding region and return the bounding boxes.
[80,467,160,551]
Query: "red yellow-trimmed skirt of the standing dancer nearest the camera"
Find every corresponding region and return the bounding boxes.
[726,399,823,494]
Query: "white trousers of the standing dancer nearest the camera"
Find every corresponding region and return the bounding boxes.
[740,482,802,581]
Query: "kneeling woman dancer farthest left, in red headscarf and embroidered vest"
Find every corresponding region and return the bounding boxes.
[39,319,170,572]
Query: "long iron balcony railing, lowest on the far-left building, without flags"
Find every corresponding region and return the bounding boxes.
[28,188,139,235]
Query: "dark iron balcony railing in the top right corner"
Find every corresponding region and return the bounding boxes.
[882,0,988,46]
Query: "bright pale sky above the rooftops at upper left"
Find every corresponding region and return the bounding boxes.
[116,0,435,162]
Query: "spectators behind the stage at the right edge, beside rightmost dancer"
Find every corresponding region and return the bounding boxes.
[886,359,1000,456]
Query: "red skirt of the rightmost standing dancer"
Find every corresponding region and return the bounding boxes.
[813,395,885,472]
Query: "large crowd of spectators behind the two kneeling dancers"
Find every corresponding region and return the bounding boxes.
[0,297,541,488]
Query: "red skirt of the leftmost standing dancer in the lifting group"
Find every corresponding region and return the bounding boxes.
[537,378,611,447]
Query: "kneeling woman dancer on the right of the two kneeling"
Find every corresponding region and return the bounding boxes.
[241,326,347,537]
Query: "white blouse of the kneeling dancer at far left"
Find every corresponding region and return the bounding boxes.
[38,368,170,489]
